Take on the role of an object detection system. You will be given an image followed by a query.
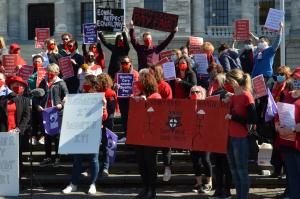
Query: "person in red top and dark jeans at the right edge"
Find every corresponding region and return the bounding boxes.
[275,67,300,199]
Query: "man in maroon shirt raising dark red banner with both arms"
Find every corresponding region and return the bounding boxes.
[129,20,178,71]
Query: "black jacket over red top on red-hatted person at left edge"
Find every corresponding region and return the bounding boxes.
[0,93,30,134]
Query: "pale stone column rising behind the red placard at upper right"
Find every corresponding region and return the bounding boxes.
[241,0,256,31]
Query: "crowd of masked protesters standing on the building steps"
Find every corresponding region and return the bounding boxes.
[0,21,300,199]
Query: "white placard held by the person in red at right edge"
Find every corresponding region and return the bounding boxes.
[277,102,296,129]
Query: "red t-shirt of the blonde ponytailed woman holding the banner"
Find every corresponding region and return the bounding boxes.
[229,91,255,137]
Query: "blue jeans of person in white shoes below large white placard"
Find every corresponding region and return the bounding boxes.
[71,153,99,185]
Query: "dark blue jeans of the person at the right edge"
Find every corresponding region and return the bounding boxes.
[283,151,300,199]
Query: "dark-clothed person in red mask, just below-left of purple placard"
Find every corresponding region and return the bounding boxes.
[65,39,84,94]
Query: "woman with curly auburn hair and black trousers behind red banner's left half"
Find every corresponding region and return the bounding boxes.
[135,73,161,199]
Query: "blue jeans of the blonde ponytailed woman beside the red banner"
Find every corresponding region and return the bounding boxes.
[227,137,250,199]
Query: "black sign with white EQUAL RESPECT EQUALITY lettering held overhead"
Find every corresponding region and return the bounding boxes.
[96,8,124,32]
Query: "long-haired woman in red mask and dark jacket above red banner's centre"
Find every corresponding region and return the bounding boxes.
[170,55,197,99]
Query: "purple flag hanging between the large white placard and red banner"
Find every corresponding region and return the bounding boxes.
[106,128,118,166]
